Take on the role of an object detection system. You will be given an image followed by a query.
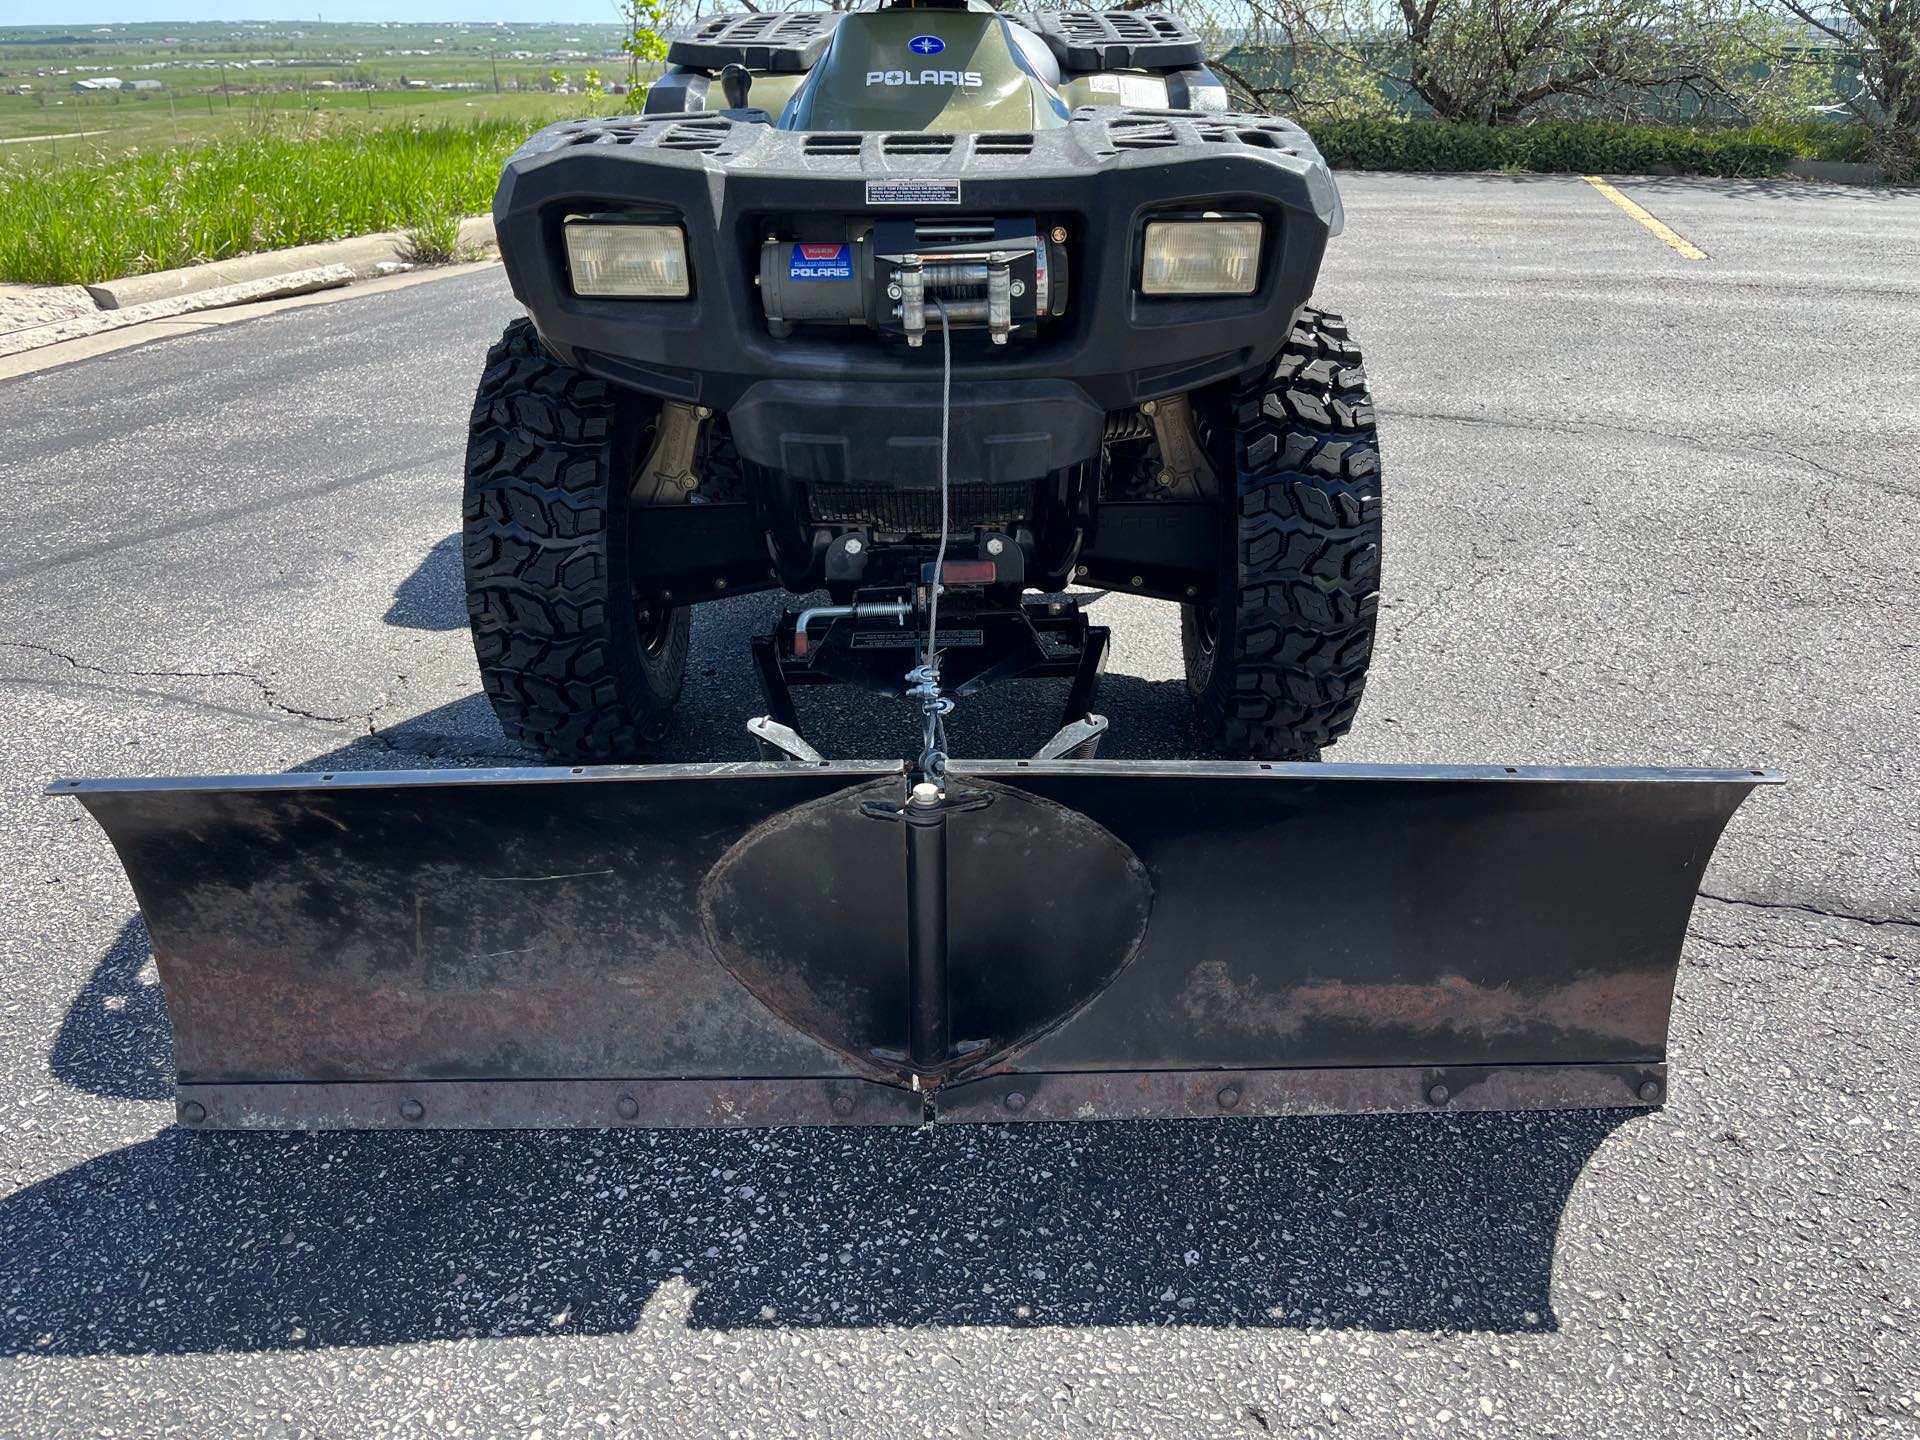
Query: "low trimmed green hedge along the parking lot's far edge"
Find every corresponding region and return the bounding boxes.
[1313,119,1797,177]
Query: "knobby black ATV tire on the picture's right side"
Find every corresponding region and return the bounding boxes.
[1181,309,1380,760]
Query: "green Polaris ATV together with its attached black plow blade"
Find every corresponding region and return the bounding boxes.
[52,4,1778,1129]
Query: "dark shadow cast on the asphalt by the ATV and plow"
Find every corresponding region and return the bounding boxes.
[22,591,1626,1356]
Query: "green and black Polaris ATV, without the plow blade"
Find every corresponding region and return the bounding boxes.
[465,0,1380,762]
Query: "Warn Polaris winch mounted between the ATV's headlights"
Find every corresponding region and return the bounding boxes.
[758,217,1068,346]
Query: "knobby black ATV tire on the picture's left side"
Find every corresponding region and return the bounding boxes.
[463,319,689,762]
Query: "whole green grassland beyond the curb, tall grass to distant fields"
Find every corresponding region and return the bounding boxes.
[0,22,645,284]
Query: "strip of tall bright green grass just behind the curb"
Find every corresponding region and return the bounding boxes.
[0,119,556,284]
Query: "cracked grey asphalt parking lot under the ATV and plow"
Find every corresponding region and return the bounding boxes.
[0,175,1920,1436]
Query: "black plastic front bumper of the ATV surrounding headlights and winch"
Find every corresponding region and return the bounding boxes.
[493,108,1340,486]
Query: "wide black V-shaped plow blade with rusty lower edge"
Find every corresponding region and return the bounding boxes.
[50,760,1778,1129]
